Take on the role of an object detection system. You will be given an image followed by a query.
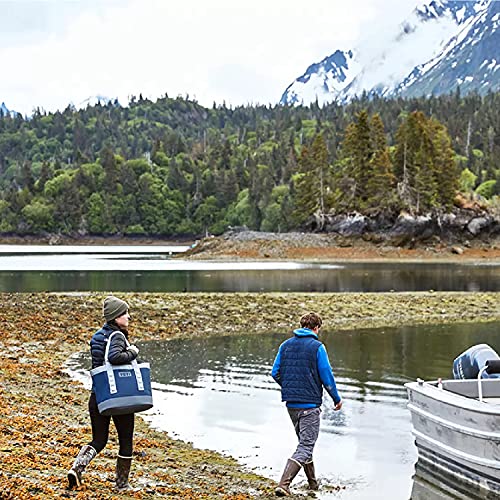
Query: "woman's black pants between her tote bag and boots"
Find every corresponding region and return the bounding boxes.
[89,393,134,457]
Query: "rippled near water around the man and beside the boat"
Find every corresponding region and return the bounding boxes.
[69,322,500,500]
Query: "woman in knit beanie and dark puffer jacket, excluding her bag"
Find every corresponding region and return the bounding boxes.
[68,295,139,490]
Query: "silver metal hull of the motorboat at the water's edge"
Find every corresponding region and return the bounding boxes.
[406,381,500,496]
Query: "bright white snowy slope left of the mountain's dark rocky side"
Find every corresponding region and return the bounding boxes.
[280,0,500,104]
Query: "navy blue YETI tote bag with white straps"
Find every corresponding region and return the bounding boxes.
[90,331,153,415]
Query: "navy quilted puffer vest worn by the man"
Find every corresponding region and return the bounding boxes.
[280,335,323,406]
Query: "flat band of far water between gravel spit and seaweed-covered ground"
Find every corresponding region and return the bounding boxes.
[0,245,500,292]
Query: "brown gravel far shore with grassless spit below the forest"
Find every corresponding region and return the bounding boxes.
[0,231,500,263]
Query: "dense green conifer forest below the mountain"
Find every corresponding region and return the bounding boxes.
[0,92,500,236]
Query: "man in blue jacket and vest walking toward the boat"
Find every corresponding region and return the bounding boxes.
[272,312,342,497]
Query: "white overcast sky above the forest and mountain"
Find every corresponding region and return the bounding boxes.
[0,0,419,114]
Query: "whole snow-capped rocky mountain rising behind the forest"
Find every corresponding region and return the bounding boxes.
[280,0,500,105]
